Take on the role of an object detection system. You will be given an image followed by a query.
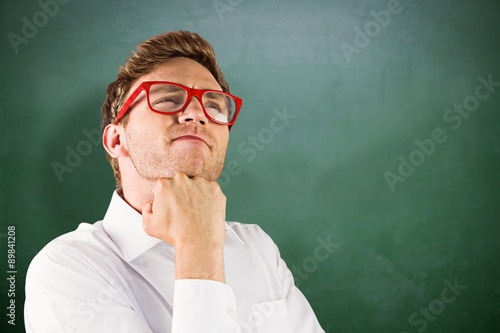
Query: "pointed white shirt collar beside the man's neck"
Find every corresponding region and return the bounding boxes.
[103,191,162,262]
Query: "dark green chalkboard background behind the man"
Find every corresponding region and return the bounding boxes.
[0,0,500,333]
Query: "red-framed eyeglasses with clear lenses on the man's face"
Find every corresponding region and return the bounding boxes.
[115,81,243,129]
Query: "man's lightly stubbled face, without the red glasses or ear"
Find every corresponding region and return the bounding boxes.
[121,58,229,180]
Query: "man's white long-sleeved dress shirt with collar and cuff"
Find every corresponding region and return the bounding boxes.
[24,192,324,333]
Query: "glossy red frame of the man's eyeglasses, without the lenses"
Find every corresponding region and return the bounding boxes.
[115,81,243,129]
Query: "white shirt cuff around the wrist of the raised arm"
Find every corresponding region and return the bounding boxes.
[172,279,238,333]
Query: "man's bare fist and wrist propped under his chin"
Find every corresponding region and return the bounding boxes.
[142,173,226,281]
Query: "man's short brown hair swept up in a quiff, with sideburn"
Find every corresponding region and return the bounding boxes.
[101,31,229,188]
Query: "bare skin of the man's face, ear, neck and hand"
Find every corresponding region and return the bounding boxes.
[103,58,229,282]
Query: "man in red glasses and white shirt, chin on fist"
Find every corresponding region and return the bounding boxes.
[25,31,323,333]
